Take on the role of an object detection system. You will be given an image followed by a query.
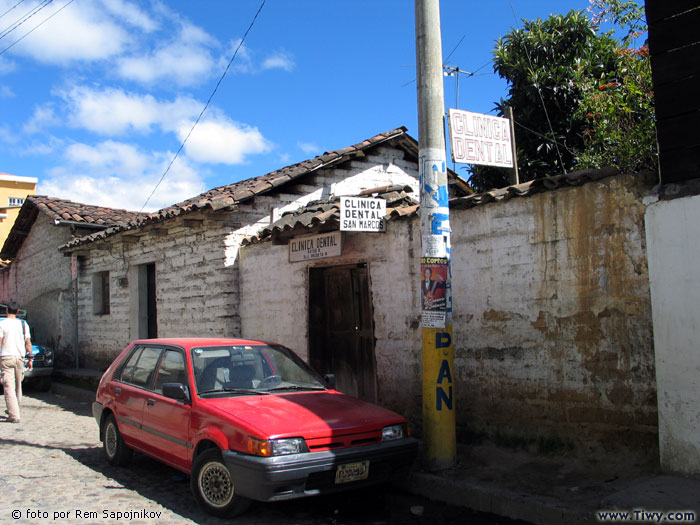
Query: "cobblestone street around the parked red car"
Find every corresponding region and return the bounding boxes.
[0,391,508,525]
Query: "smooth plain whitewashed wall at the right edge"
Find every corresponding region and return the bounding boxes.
[646,192,700,475]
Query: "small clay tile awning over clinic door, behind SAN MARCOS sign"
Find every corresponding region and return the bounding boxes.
[243,185,418,245]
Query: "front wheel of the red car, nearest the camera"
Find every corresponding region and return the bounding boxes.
[190,449,250,517]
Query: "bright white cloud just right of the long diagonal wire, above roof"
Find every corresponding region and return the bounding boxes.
[178,118,272,164]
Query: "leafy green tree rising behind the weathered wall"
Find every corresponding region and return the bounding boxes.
[470,0,655,191]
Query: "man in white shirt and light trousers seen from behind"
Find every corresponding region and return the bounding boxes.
[0,303,32,423]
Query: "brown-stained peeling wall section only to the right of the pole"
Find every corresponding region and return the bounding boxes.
[451,176,657,455]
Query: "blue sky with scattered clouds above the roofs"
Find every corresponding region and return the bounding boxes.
[0,0,589,211]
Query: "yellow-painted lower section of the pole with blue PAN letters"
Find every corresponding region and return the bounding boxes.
[423,325,457,470]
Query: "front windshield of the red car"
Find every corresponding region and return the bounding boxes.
[192,345,326,395]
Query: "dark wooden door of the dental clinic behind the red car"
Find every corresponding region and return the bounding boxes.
[309,264,377,401]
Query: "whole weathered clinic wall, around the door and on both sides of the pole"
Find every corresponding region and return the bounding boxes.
[240,171,657,457]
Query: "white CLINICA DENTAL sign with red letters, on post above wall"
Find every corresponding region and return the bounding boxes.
[448,109,513,168]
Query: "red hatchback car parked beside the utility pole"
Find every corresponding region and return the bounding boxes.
[92,338,418,516]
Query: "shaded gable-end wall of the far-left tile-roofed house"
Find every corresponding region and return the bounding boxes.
[0,213,75,366]
